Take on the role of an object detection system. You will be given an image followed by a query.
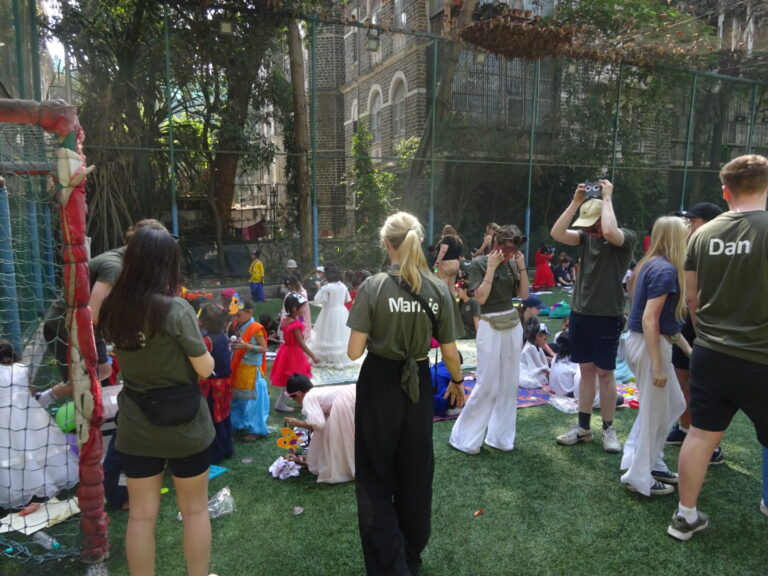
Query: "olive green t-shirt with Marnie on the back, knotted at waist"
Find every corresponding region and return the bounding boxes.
[347,267,464,360]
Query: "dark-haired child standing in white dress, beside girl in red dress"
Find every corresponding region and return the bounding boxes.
[312,264,351,368]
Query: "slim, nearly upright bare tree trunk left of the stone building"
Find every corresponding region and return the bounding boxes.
[288,20,315,266]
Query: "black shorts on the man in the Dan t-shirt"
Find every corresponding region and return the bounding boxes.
[689,345,768,446]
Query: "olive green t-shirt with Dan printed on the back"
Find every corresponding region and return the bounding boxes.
[685,210,768,364]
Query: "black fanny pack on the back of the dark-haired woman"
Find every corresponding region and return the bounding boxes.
[123,384,201,426]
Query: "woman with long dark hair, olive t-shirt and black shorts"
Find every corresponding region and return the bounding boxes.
[99,223,215,576]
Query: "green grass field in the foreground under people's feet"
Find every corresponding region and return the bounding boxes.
[0,295,768,576]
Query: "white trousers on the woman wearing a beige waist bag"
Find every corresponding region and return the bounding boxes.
[449,320,523,454]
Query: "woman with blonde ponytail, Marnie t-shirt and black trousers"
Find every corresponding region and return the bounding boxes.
[347,212,464,574]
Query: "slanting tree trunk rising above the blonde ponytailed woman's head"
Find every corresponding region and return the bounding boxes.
[401,0,477,210]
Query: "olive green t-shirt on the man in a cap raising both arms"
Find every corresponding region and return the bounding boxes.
[571,228,637,316]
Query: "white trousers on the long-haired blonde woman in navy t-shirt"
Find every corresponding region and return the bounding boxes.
[620,332,685,496]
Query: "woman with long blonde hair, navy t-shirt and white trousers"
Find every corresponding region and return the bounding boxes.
[620,216,691,496]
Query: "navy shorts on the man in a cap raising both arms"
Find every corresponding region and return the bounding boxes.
[568,312,624,370]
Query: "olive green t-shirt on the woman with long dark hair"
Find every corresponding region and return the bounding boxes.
[112,298,215,458]
